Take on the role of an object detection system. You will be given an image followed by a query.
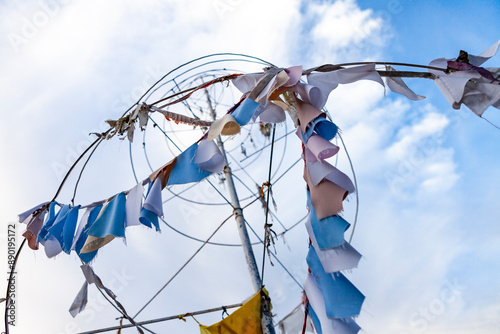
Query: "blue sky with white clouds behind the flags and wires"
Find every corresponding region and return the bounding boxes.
[0,0,500,334]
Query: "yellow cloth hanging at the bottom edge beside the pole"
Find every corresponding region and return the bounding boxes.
[200,290,263,334]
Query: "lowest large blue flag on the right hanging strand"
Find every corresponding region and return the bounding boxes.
[307,247,365,318]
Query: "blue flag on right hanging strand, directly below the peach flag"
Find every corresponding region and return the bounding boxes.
[307,191,351,249]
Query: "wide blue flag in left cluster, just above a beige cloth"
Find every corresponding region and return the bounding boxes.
[88,193,126,238]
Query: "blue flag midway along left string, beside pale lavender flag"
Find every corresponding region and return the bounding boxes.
[167,143,212,185]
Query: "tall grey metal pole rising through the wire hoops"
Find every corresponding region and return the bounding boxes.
[205,89,275,334]
